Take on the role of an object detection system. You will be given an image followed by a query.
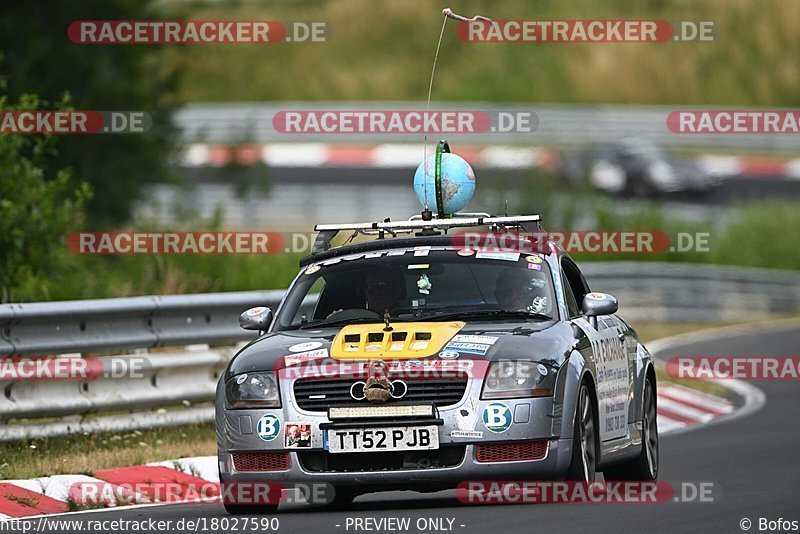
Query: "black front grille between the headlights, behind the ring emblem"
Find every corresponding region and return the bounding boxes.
[294,375,469,412]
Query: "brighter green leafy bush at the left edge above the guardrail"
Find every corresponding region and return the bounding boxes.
[0,94,91,302]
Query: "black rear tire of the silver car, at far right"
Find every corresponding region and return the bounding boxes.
[603,380,658,482]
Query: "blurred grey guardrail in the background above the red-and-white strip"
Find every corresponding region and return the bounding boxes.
[173,101,800,151]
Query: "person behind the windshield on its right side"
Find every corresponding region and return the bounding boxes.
[494,267,550,314]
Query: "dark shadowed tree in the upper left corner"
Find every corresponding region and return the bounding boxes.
[0,0,176,227]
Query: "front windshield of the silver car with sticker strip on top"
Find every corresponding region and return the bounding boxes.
[274,247,557,330]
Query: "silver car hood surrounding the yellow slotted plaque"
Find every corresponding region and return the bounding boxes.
[225,321,575,380]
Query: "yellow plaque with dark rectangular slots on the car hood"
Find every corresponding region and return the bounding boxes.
[331,321,466,360]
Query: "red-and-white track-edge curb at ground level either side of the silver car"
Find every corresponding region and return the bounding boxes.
[0,384,733,520]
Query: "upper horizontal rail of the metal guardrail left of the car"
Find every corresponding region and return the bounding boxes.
[0,291,283,356]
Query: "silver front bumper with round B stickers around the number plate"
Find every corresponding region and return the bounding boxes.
[217,374,572,491]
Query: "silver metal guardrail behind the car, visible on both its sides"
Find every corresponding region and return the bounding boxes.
[0,262,800,441]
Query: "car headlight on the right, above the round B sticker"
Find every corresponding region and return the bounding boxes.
[481,361,556,400]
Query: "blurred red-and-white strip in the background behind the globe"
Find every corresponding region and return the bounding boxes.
[177,142,800,180]
